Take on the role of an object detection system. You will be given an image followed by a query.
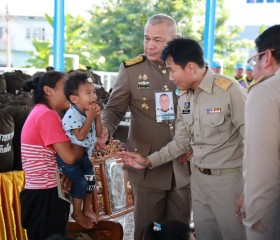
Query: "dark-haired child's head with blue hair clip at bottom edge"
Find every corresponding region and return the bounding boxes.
[141,220,194,240]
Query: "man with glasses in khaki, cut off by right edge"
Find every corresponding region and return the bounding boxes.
[243,25,280,240]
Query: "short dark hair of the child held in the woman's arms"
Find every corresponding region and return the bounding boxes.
[64,70,92,101]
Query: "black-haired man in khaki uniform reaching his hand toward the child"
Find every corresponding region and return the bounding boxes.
[119,39,246,240]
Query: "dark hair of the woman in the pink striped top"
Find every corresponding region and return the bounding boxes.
[23,71,66,105]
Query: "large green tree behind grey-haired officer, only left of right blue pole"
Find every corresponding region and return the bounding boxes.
[87,0,207,71]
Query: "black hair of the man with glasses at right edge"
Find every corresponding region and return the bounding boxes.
[255,24,280,64]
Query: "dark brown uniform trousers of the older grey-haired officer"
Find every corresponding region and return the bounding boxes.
[132,180,191,240]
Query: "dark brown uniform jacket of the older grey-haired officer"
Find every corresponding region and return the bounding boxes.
[102,56,190,190]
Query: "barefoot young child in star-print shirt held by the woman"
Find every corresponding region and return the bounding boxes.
[57,71,102,228]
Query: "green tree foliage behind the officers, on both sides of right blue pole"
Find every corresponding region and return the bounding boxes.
[87,0,253,75]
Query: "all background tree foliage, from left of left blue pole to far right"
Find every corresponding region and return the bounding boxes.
[25,0,255,72]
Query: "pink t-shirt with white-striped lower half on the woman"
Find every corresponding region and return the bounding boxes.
[21,104,70,189]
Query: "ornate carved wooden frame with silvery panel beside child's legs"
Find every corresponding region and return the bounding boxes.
[91,139,133,219]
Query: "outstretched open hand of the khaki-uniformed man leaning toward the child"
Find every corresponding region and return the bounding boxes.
[115,152,152,169]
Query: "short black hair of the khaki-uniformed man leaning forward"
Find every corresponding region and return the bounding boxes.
[161,38,205,68]
